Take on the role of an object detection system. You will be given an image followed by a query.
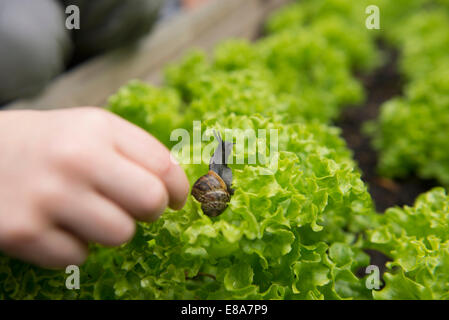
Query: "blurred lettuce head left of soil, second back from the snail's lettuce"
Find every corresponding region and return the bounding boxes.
[257,29,363,108]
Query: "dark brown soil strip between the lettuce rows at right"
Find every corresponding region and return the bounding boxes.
[336,45,437,213]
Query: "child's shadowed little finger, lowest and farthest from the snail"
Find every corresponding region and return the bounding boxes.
[3,228,88,268]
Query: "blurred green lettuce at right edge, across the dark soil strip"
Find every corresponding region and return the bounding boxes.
[367,64,449,187]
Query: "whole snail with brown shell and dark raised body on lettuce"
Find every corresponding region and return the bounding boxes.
[192,131,234,217]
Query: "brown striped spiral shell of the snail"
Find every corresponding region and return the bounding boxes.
[192,170,231,217]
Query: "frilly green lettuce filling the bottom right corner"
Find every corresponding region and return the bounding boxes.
[368,188,449,299]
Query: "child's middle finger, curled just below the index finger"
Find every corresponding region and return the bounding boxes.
[90,153,168,221]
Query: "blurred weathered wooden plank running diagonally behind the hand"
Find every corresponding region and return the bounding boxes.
[6,0,288,109]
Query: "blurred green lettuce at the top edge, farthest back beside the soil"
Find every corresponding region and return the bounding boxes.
[267,0,382,73]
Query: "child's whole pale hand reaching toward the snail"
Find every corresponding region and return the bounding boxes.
[0,108,189,267]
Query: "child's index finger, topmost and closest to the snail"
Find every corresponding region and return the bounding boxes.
[105,111,189,209]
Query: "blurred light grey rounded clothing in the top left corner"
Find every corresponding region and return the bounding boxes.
[0,0,71,104]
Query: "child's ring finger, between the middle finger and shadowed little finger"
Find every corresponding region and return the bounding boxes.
[51,190,136,246]
